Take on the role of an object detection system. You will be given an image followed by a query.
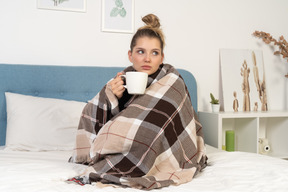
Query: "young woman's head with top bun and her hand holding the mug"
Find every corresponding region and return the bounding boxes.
[110,14,165,98]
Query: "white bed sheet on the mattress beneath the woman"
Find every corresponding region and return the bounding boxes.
[0,146,288,192]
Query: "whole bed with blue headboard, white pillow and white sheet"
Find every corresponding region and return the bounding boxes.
[0,64,288,192]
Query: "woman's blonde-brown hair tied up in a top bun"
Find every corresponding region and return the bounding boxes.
[130,14,165,53]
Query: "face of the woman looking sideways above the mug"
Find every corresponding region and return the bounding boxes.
[128,37,164,75]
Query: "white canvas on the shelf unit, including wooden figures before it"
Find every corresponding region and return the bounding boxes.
[220,49,268,111]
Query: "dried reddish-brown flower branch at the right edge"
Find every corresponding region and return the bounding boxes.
[253,31,288,78]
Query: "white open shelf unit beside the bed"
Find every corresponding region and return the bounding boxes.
[198,111,288,158]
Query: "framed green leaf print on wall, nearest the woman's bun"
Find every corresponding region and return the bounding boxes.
[102,0,134,33]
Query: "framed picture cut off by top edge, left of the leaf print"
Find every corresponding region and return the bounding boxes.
[37,0,86,12]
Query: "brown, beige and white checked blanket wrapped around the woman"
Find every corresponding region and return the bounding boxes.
[70,64,207,190]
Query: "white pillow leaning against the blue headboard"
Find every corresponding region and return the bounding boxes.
[5,92,86,151]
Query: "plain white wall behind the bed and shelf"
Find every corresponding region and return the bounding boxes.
[0,0,288,111]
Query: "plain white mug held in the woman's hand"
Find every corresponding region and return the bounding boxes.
[121,71,148,95]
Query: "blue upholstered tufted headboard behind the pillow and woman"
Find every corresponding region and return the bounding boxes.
[0,64,197,145]
